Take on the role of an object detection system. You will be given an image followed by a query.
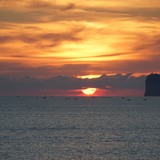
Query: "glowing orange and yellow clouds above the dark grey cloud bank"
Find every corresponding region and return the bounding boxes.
[0,0,160,77]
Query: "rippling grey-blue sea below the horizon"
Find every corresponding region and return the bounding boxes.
[0,97,160,160]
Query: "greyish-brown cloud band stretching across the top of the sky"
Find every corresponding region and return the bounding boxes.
[0,0,160,23]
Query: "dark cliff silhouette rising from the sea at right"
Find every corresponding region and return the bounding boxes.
[145,73,160,96]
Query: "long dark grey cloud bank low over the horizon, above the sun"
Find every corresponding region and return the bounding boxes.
[0,74,145,95]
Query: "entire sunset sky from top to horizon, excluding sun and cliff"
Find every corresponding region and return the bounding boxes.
[0,0,160,96]
